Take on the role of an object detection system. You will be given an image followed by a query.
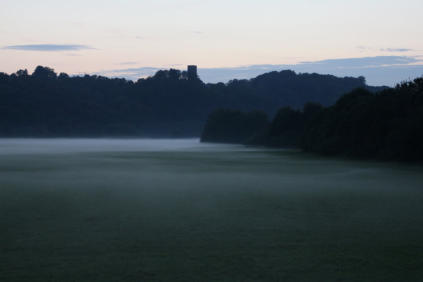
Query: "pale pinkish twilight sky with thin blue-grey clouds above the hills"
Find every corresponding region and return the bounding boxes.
[0,0,423,85]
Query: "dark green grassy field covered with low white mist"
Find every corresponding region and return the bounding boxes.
[0,139,423,281]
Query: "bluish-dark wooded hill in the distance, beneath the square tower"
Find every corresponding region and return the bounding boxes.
[0,66,383,137]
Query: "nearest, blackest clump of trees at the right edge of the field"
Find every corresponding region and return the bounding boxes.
[302,78,423,160]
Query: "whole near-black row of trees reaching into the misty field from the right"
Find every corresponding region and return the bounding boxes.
[202,78,423,161]
